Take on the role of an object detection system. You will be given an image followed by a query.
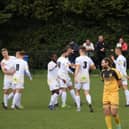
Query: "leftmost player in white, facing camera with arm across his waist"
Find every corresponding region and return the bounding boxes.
[1,48,16,109]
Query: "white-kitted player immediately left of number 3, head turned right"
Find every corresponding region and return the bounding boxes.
[57,47,76,108]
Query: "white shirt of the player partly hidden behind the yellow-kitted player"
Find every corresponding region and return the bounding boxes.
[114,55,127,76]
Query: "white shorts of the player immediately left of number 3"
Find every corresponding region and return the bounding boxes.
[59,78,72,88]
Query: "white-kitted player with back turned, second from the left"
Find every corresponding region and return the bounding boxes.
[11,51,32,109]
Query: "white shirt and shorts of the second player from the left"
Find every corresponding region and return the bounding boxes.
[13,58,32,89]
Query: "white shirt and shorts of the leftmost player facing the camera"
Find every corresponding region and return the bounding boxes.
[1,56,16,89]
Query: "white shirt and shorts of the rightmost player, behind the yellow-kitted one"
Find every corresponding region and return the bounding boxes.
[114,55,128,85]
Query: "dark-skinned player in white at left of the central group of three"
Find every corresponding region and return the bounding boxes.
[47,54,59,110]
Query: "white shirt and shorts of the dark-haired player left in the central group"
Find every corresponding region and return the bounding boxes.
[47,61,59,91]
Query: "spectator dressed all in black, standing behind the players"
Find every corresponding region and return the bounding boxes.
[95,35,106,69]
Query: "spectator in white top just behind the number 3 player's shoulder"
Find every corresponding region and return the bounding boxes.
[83,39,95,58]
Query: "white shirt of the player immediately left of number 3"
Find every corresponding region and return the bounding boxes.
[57,56,70,80]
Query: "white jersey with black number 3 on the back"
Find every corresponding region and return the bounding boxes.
[75,56,94,82]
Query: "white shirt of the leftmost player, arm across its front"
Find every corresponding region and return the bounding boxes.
[1,56,16,80]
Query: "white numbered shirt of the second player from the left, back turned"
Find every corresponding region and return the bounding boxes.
[14,59,30,79]
